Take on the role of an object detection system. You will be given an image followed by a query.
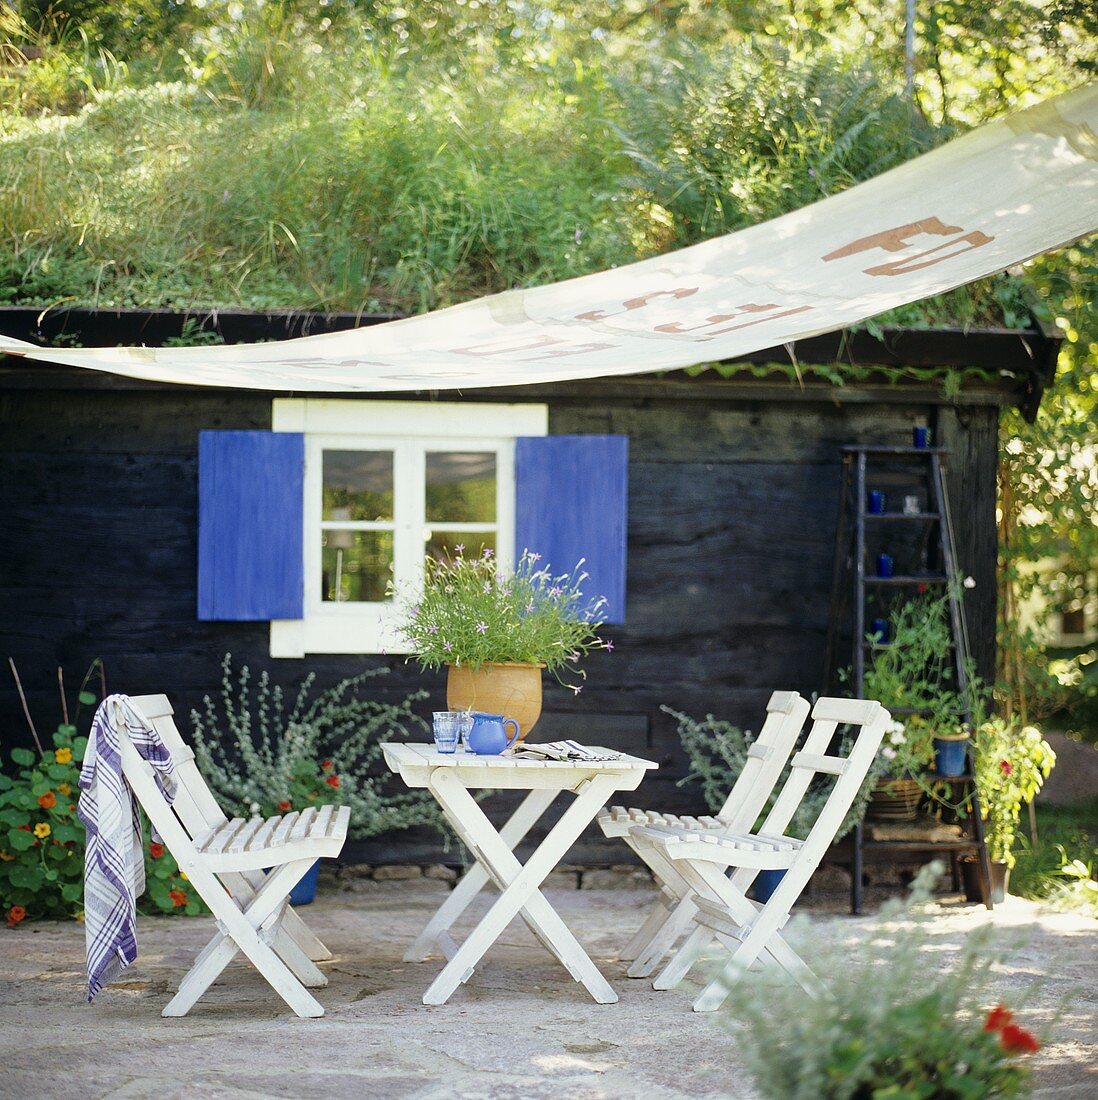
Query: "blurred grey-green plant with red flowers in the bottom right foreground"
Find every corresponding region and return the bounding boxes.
[726,862,1040,1100]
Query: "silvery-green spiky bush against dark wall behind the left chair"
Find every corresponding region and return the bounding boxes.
[190,653,441,838]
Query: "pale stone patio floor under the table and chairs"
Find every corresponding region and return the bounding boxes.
[0,879,1098,1100]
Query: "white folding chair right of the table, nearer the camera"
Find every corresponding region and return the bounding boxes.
[633,699,891,1012]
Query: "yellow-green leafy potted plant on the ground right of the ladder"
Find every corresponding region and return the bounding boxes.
[975,717,1056,902]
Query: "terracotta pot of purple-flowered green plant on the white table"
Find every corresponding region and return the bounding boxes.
[399,547,613,739]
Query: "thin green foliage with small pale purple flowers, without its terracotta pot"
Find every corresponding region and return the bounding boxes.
[399,547,613,690]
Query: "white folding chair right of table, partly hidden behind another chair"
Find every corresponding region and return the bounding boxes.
[599,691,809,978]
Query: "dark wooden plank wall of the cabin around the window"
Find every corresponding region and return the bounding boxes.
[0,384,998,862]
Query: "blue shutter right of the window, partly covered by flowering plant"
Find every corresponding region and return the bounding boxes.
[515,436,629,623]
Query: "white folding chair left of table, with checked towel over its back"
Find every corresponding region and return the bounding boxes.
[121,695,351,1016]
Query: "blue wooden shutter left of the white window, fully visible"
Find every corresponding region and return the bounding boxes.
[198,431,305,622]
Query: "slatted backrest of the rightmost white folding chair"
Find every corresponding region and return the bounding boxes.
[759,699,892,866]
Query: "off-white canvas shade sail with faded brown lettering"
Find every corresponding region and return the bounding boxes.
[0,84,1098,393]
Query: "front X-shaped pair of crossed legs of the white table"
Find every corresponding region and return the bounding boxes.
[424,768,617,1004]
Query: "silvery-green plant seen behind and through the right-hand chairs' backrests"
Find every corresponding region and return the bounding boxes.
[660,706,872,839]
